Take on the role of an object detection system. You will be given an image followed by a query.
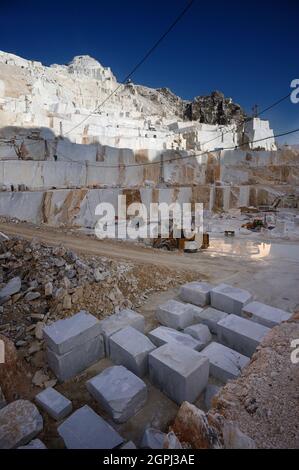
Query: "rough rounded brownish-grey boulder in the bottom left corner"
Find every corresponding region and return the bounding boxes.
[0,400,43,449]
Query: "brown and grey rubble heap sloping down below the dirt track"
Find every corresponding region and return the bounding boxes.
[0,238,196,387]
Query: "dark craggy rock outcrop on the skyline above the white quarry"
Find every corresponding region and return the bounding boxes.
[185,91,246,125]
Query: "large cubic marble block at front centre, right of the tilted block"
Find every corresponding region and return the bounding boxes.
[149,343,209,405]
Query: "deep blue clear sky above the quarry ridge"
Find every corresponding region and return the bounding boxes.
[0,0,299,143]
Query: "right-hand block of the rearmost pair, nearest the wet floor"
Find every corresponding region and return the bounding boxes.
[211,284,252,315]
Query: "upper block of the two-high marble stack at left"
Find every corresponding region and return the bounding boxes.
[43,310,100,354]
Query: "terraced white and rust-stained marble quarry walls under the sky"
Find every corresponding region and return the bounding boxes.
[0,51,299,228]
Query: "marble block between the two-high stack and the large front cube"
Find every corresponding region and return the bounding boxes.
[110,326,156,377]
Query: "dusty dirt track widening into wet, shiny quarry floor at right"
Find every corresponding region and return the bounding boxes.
[0,223,299,311]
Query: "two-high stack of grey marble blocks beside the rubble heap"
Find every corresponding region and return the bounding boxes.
[44,311,105,382]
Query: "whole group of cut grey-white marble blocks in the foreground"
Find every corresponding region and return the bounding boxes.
[39,282,291,448]
